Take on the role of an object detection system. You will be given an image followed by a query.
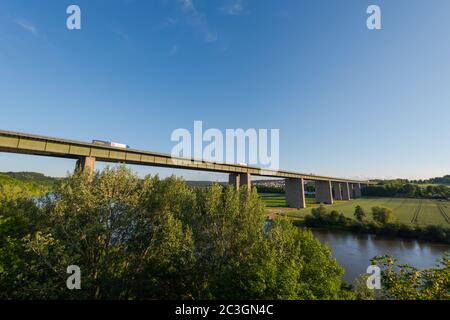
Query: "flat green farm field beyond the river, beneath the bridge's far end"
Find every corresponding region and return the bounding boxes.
[261,194,450,226]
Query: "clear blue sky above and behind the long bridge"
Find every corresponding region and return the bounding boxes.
[0,0,450,179]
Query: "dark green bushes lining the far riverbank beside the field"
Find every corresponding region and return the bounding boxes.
[295,206,450,244]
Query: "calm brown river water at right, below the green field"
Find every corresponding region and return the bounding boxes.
[312,229,450,283]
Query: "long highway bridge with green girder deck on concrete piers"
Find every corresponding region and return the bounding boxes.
[0,130,370,208]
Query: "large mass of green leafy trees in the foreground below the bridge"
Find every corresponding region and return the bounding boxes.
[0,167,353,299]
